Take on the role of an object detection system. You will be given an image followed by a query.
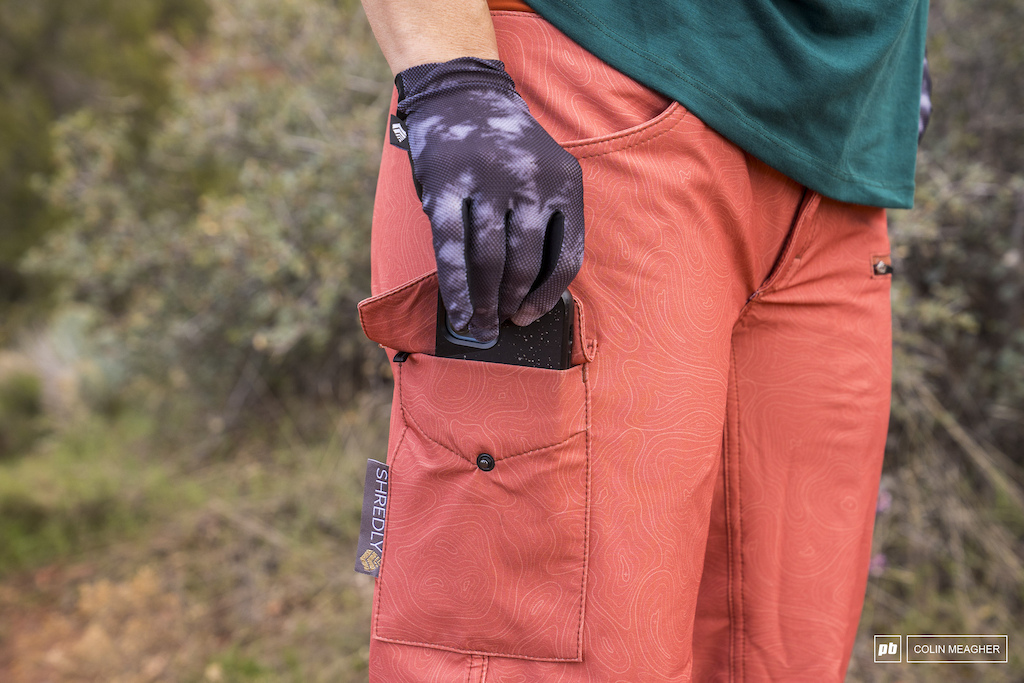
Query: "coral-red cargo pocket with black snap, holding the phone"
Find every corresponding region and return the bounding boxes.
[360,272,595,661]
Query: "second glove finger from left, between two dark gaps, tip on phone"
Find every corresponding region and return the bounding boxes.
[463,199,506,342]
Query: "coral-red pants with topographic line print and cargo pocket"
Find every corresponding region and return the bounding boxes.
[364,12,891,683]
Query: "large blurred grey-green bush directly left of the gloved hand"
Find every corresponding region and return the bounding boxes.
[26,0,390,426]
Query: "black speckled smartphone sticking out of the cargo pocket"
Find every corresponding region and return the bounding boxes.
[434,290,573,370]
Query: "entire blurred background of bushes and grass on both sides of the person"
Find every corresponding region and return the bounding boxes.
[0,0,1024,681]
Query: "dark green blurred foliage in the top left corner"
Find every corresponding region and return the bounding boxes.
[0,0,208,321]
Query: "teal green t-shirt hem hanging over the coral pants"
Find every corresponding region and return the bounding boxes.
[528,0,928,208]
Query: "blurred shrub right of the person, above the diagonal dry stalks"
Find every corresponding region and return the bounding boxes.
[891,0,1024,467]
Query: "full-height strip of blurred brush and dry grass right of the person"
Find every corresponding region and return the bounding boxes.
[851,0,1024,681]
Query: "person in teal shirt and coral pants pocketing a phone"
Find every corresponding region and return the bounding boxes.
[359,0,927,683]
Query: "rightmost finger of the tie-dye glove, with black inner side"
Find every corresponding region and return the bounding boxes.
[512,201,584,326]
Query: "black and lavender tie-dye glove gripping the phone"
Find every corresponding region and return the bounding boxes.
[395,57,584,342]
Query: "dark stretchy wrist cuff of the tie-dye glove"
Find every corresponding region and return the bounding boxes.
[394,57,518,119]
